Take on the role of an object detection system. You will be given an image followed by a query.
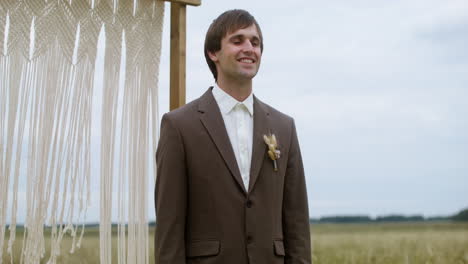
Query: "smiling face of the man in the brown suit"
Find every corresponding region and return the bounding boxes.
[209,24,262,83]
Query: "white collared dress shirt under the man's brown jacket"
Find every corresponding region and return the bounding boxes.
[213,84,253,191]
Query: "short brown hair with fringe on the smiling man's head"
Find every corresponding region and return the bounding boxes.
[205,9,263,80]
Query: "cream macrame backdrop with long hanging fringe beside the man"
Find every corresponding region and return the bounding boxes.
[0,0,164,263]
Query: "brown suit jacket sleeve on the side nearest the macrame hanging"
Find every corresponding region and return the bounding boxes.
[154,114,187,264]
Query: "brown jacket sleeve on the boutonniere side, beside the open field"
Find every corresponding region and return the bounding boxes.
[283,122,311,264]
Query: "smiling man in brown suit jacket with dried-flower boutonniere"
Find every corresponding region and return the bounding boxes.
[155,10,311,264]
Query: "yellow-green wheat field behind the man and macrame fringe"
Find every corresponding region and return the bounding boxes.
[3,222,468,264]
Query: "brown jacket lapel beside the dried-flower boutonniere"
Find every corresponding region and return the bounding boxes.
[249,96,270,192]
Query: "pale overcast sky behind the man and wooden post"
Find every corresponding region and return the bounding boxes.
[154,0,468,217]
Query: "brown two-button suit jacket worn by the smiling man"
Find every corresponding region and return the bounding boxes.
[155,88,311,264]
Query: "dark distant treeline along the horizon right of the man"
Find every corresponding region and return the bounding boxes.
[310,208,468,223]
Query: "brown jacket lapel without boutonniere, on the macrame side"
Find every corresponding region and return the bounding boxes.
[198,87,249,193]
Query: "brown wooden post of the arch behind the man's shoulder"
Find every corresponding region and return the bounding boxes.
[165,0,201,110]
